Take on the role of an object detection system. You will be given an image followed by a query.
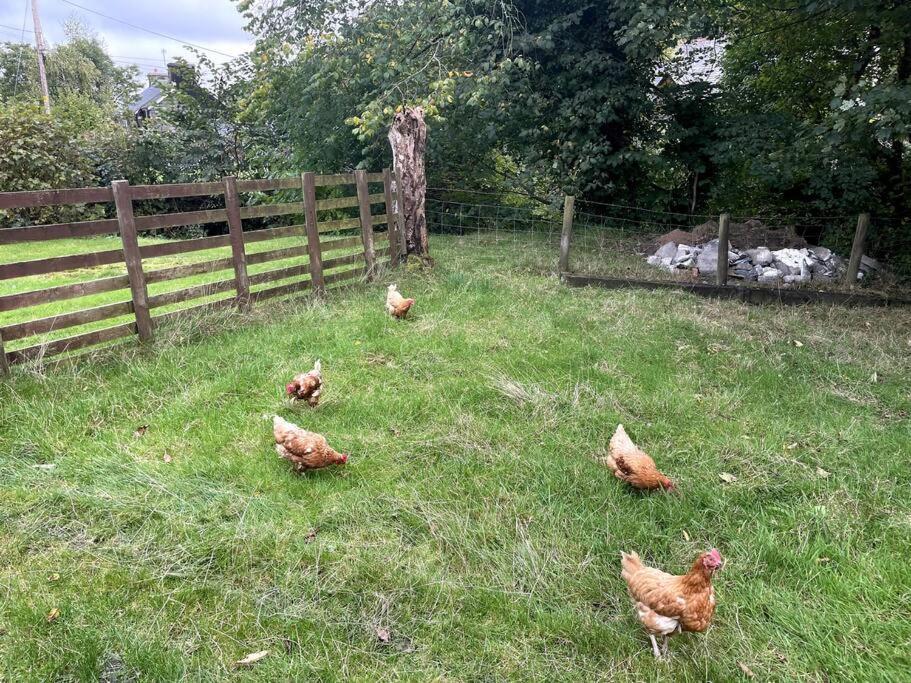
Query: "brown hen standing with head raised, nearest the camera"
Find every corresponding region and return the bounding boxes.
[620,549,723,658]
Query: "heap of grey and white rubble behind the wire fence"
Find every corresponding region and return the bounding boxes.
[647,221,879,284]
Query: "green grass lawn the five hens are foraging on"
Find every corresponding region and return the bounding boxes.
[0,237,911,681]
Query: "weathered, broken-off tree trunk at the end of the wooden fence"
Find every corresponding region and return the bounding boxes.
[389,107,430,263]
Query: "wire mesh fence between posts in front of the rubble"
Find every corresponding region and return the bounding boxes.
[427,188,911,294]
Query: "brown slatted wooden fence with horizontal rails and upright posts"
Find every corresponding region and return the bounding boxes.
[0,169,405,374]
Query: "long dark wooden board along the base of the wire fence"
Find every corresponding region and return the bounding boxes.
[562,273,911,306]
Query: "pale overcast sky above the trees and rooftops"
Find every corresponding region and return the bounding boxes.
[0,0,253,74]
